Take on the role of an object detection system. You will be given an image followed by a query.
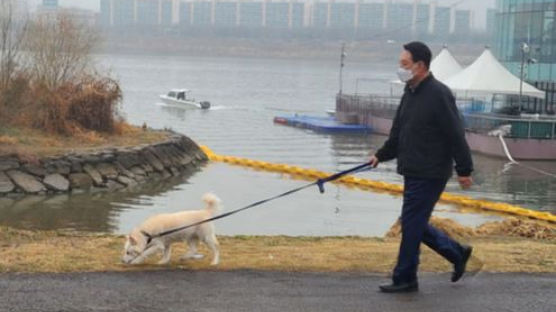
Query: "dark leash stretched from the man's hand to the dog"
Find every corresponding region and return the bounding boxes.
[141,162,371,245]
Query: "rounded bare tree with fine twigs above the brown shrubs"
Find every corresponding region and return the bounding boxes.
[25,12,99,90]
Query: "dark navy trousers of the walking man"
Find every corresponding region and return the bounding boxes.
[392,177,462,283]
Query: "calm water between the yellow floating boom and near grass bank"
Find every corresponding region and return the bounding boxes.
[0,163,504,236]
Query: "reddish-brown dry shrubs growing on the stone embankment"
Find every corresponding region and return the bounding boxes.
[0,74,122,136]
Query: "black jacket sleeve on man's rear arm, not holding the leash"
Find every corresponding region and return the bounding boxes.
[436,90,473,177]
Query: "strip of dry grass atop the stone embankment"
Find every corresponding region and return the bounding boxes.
[0,122,169,159]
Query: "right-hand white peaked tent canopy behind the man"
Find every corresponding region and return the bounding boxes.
[444,48,545,99]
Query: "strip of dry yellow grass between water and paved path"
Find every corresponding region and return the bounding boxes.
[0,228,556,273]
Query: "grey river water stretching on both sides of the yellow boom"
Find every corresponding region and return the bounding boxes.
[0,55,556,236]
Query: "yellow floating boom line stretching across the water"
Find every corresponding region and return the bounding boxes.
[201,146,556,223]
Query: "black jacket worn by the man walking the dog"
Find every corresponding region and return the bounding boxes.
[376,74,473,178]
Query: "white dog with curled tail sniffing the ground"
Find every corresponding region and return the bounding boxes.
[122,193,220,265]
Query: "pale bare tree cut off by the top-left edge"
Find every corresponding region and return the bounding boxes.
[0,0,27,89]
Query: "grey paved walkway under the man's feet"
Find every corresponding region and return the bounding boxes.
[0,271,556,312]
